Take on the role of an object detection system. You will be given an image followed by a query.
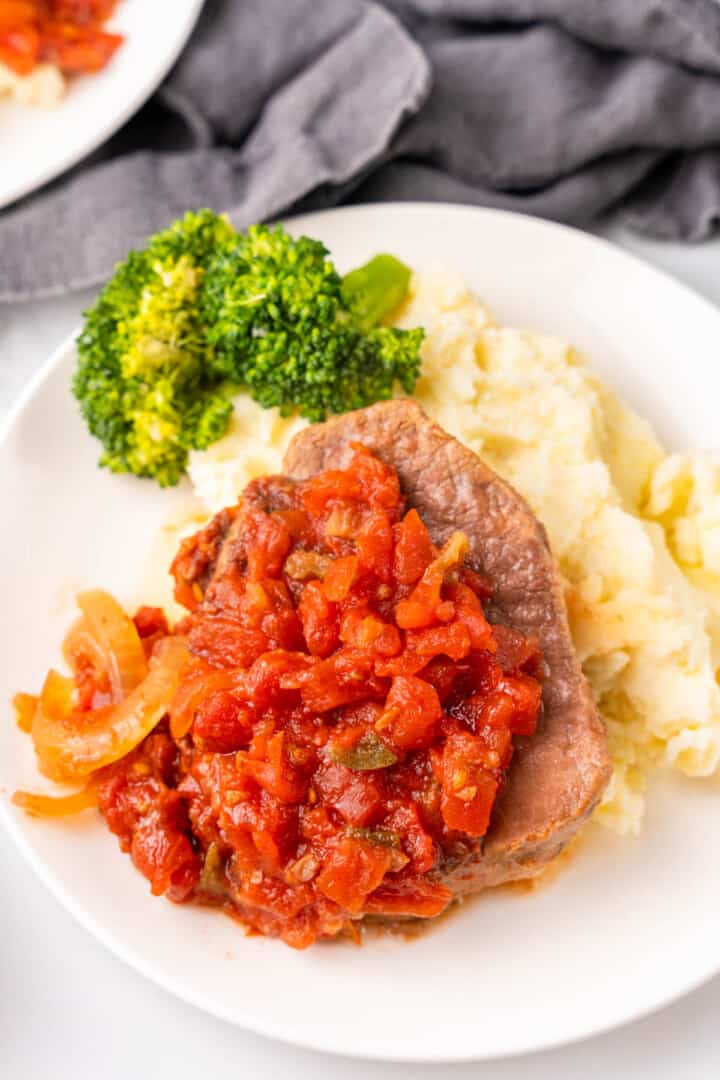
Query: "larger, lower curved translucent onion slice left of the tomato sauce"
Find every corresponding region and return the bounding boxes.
[31,637,190,781]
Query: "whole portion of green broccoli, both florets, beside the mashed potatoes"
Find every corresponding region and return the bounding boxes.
[72,210,422,486]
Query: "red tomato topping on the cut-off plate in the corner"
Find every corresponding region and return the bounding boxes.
[0,0,123,76]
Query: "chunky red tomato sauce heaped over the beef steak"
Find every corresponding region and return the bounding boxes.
[96,446,541,948]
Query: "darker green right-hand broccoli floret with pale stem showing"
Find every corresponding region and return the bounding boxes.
[201,226,423,420]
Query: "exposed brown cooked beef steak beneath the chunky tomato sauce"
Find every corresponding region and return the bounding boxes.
[284,400,611,895]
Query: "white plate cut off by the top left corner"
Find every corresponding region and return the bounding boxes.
[0,0,203,207]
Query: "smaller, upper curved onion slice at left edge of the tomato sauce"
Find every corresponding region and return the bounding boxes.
[75,589,148,703]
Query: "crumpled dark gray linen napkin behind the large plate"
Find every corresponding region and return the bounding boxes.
[0,0,720,301]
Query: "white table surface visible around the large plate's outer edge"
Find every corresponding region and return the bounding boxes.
[0,219,720,1080]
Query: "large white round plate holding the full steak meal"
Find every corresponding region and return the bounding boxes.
[0,204,720,1061]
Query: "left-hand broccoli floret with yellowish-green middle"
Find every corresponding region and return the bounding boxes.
[72,211,236,486]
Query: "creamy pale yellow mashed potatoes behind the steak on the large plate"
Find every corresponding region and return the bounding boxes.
[190,263,720,833]
